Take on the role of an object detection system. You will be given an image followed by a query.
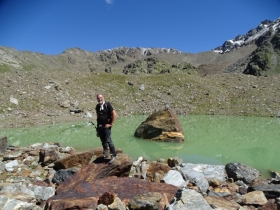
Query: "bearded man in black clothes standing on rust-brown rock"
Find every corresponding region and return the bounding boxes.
[95,94,117,164]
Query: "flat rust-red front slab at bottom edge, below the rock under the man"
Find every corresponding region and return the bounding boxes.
[45,175,179,210]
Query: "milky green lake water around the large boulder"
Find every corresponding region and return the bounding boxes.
[0,115,280,177]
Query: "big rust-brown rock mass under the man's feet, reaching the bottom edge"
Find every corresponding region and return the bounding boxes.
[45,154,179,210]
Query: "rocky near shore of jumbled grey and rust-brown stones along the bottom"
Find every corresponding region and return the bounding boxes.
[0,137,280,210]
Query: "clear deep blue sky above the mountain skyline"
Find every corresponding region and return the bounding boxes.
[0,0,280,55]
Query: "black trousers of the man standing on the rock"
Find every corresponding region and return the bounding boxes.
[98,128,116,156]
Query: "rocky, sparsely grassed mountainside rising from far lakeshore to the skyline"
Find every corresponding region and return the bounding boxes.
[0,19,280,127]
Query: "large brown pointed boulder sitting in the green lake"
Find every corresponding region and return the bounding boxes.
[134,108,184,142]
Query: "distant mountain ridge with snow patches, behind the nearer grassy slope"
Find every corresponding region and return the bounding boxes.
[0,18,280,75]
